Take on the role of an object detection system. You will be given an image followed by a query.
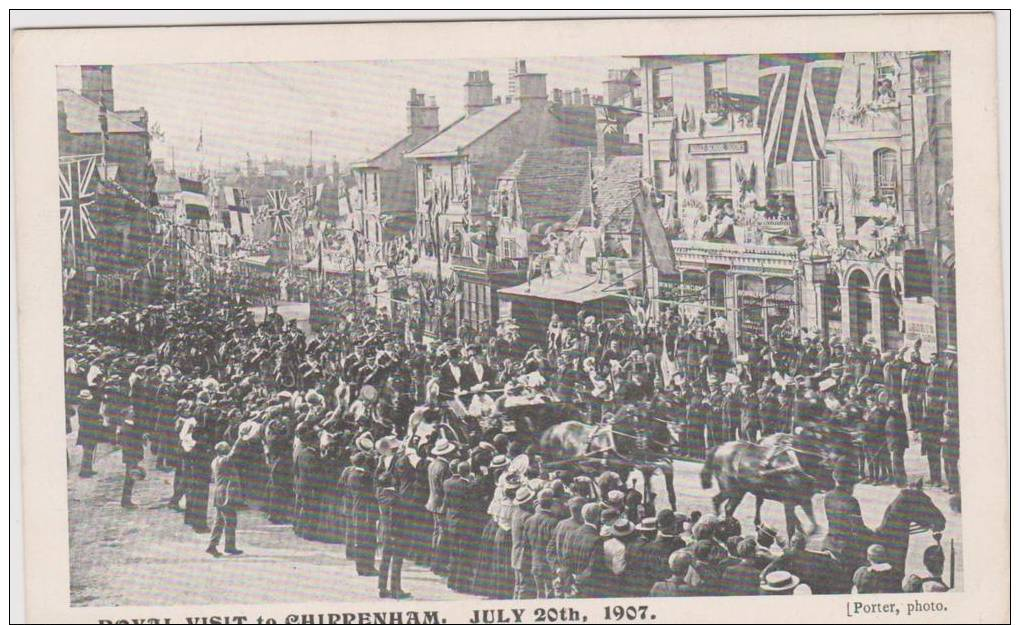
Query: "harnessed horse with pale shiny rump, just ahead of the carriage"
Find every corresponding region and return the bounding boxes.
[533,403,676,509]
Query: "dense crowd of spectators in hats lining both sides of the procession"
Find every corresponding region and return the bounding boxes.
[64,279,959,598]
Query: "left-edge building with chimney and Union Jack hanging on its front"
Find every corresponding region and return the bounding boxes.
[57,65,160,318]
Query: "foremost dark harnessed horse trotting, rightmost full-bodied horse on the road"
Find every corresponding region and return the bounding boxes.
[701,434,834,535]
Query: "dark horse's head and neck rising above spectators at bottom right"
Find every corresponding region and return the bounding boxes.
[872,479,946,573]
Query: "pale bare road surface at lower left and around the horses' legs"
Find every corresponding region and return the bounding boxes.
[67,424,963,606]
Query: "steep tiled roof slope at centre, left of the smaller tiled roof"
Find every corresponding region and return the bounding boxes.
[500,148,592,227]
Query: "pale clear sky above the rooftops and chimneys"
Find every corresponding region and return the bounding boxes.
[57,57,634,171]
